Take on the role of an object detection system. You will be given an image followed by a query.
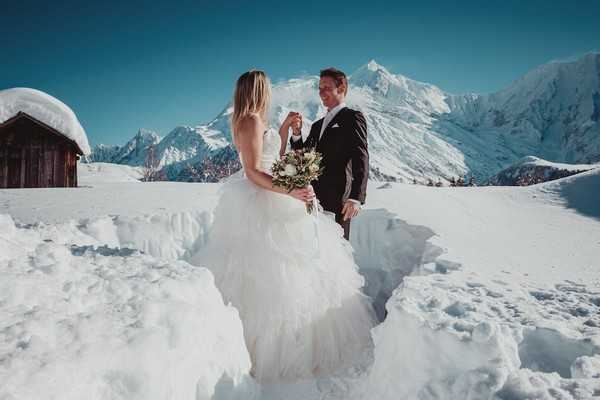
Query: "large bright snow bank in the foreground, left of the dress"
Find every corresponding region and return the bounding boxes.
[0,216,254,400]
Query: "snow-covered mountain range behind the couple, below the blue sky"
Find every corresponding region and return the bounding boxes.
[85,53,600,181]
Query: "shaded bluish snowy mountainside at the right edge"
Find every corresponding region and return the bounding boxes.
[447,53,600,163]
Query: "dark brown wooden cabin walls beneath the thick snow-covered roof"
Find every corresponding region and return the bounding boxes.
[0,112,83,188]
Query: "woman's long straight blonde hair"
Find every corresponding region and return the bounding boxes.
[231,70,271,134]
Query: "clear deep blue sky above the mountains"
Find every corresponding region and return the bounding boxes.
[0,0,600,144]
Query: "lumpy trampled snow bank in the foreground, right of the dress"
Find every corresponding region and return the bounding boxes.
[353,271,600,400]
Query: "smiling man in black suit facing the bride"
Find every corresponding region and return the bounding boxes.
[290,68,369,239]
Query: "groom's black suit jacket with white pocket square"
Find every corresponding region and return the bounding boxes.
[290,107,369,214]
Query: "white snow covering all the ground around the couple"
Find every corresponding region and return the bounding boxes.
[0,169,600,400]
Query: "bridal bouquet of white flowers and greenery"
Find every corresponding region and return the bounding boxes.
[271,149,323,214]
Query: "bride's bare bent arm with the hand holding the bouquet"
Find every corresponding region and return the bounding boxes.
[237,116,314,201]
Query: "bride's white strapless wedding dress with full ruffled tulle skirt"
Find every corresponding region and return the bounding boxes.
[192,129,375,382]
